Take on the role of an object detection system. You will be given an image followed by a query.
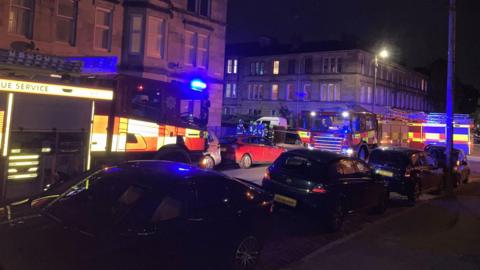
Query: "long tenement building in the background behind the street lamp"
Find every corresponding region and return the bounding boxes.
[223,46,428,123]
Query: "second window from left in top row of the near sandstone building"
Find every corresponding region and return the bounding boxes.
[56,0,77,45]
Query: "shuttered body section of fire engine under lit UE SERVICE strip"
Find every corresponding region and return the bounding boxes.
[0,78,113,201]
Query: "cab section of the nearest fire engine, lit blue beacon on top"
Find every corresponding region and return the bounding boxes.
[91,75,209,169]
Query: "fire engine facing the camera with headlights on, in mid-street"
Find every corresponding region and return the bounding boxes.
[298,108,378,159]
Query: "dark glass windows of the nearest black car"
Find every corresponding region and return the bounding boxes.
[44,167,184,232]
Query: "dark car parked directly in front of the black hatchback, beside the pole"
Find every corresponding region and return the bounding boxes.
[368,147,443,203]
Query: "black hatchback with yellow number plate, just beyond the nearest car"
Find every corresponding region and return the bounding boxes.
[262,149,388,230]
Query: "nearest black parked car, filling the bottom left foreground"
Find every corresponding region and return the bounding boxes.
[0,161,273,270]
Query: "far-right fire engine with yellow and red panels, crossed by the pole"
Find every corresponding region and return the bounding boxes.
[408,113,473,155]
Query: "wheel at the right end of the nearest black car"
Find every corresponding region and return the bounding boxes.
[233,235,262,270]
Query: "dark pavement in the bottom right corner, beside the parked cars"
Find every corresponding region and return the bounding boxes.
[283,177,480,270]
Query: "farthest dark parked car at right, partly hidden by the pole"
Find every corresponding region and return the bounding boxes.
[425,145,470,186]
